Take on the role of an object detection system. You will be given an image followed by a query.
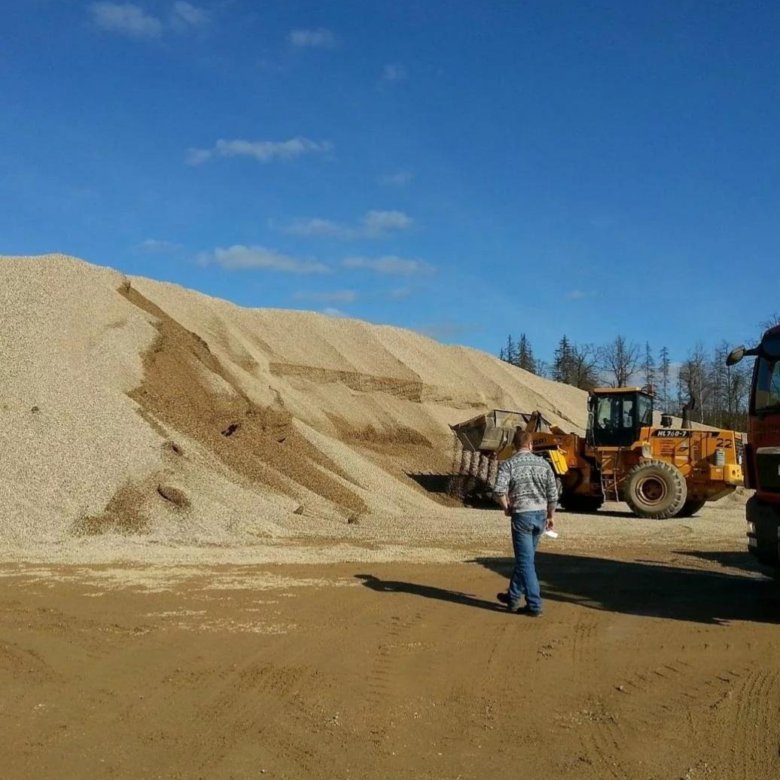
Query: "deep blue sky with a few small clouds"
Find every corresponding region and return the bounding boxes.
[0,0,780,360]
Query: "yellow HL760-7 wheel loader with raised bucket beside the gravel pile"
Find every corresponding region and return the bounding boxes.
[450,387,743,519]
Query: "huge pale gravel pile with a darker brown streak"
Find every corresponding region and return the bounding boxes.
[0,256,585,546]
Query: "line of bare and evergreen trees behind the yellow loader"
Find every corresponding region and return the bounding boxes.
[499,313,780,430]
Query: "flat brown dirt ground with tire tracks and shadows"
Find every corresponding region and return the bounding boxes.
[0,504,780,780]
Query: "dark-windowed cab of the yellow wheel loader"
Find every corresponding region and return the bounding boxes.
[588,387,653,447]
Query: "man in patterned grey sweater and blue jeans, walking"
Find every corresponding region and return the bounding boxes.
[493,428,558,617]
